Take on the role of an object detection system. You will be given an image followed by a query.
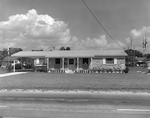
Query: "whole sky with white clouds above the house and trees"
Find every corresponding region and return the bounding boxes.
[0,0,150,52]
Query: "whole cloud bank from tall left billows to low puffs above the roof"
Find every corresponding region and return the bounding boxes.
[0,9,123,50]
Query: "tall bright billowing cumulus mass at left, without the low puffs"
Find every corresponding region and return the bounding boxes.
[0,9,71,50]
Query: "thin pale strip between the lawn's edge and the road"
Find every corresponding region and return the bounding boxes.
[0,89,150,95]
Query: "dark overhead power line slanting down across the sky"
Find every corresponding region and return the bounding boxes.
[82,0,125,49]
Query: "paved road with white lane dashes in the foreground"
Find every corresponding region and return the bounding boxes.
[0,91,150,118]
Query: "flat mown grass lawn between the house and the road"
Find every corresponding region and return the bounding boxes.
[0,67,150,92]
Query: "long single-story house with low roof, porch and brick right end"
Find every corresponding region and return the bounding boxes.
[12,50,127,71]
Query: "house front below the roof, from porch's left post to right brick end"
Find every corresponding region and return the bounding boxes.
[47,58,125,73]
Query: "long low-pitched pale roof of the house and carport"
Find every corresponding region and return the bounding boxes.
[12,50,127,58]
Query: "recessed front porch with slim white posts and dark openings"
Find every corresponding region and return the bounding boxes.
[47,58,92,73]
